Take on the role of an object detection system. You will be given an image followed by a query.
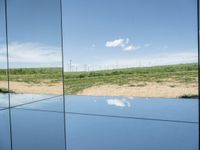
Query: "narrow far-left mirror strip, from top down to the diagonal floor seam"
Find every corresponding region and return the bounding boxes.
[0,0,9,110]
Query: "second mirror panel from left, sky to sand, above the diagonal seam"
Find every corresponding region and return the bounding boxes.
[8,0,62,106]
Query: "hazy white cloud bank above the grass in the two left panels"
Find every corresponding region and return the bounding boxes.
[0,42,61,64]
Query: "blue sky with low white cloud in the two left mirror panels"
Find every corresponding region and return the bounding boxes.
[0,0,62,67]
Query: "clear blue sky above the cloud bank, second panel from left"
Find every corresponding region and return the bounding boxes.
[8,0,60,46]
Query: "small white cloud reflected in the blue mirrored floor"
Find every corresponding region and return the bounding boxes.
[107,98,131,107]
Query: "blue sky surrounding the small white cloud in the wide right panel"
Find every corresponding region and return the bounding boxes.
[63,0,197,70]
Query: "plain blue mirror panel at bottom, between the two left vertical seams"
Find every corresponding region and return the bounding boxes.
[12,109,65,150]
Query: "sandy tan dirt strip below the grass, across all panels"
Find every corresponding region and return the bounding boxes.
[0,81,198,98]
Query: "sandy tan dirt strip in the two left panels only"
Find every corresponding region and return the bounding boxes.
[0,81,63,94]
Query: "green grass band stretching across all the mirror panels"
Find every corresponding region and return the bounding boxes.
[0,63,198,96]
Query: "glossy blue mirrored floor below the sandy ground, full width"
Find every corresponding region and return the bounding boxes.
[0,95,198,150]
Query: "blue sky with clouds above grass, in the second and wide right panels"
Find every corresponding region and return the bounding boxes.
[1,0,197,70]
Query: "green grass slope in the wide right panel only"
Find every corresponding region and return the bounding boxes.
[65,64,198,94]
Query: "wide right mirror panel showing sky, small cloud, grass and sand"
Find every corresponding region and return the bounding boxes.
[63,0,198,98]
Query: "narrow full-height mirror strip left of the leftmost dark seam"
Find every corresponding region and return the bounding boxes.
[0,0,11,150]
